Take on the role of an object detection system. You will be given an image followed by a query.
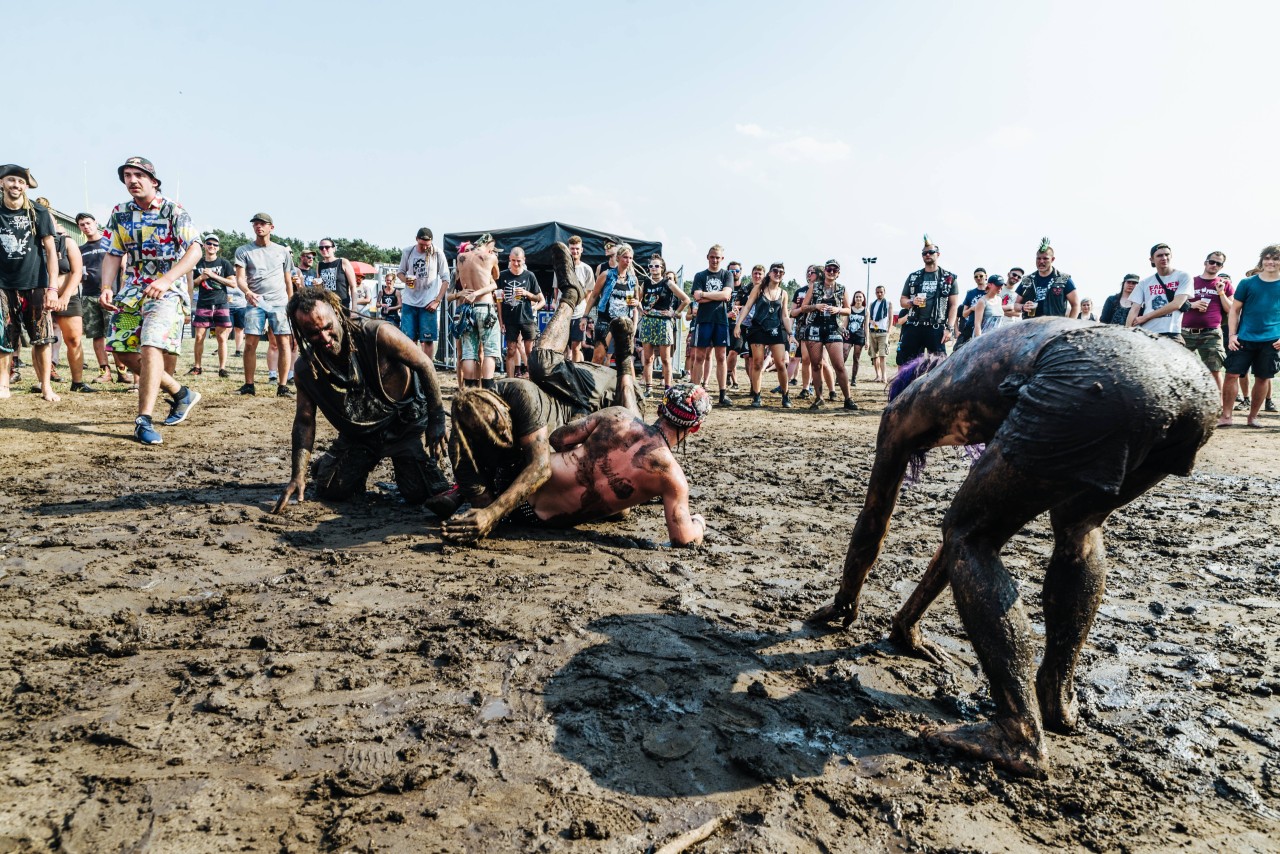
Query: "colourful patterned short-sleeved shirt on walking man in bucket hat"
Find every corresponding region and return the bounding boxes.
[102,196,200,292]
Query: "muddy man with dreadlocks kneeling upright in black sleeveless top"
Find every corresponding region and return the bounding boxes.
[273,288,449,513]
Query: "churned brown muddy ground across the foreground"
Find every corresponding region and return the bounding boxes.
[0,365,1280,851]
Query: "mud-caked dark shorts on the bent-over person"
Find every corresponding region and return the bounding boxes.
[992,326,1220,494]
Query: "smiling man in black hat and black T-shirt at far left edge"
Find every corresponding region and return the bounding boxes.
[0,163,61,401]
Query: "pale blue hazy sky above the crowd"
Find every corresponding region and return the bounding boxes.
[22,0,1280,301]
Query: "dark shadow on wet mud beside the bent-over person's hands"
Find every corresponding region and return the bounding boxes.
[544,615,927,796]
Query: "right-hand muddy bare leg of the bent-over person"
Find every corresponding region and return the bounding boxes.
[1036,471,1165,732]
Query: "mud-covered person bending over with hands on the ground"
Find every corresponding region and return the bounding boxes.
[810,318,1216,777]
